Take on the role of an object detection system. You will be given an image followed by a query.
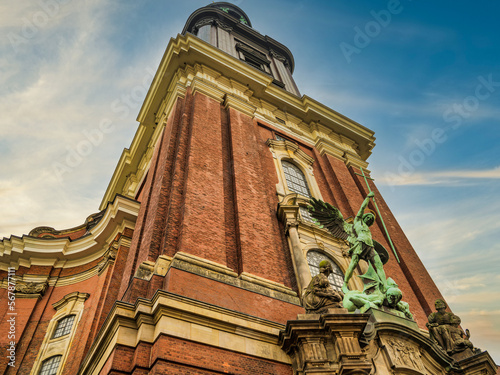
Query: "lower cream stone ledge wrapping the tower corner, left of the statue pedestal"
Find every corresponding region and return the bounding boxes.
[78,290,290,375]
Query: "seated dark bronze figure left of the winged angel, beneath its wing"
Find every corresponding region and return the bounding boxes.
[302,260,343,314]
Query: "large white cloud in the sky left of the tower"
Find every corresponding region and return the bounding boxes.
[0,1,152,237]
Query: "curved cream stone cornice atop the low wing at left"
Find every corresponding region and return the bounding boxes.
[0,196,140,270]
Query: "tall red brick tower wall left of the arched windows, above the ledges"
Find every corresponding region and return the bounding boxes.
[119,90,295,302]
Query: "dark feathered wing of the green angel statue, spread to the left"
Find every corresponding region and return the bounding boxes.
[307,198,354,240]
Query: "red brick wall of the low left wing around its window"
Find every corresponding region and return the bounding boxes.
[0,230,133,375]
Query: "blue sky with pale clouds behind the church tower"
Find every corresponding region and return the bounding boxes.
[0,0,500,363]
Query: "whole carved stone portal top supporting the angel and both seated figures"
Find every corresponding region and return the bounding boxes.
[278,309,496,375]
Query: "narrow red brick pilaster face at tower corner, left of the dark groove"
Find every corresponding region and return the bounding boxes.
[178,93,227,264]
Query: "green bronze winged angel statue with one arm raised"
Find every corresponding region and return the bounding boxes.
[309,192,387,293]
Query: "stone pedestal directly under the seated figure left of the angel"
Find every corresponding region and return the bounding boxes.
[279,309,372,375]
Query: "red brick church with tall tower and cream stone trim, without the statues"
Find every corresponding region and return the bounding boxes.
[0,2,494,375]
